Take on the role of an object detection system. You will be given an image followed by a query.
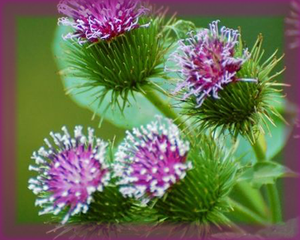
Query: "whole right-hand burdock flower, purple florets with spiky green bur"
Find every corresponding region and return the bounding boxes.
[171,21,284,144]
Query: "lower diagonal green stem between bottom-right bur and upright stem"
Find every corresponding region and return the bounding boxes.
[228,198,267,226]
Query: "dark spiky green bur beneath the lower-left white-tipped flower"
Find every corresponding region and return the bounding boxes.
[51,186,154,239]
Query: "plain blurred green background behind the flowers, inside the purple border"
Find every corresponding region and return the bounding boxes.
[16,17,284,223]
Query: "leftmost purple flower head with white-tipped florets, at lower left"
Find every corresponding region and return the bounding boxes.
[29,126,110,224]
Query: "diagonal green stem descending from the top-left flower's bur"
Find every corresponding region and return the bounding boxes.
[143,87,186,130]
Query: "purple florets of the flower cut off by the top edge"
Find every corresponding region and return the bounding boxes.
[58,0,148,44]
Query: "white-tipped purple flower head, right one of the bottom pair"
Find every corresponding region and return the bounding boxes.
[114,116,191,203]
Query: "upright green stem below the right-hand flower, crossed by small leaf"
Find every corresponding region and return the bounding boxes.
[252,135,282,223]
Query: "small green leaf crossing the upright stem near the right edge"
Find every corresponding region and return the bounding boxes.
[238,162,298,188]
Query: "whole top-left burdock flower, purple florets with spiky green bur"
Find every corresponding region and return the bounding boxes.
[55,0,175,117]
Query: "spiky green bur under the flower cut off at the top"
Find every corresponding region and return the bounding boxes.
[59,14,173,110]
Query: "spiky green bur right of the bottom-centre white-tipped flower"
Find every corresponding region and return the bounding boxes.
[153,137,239,235]
